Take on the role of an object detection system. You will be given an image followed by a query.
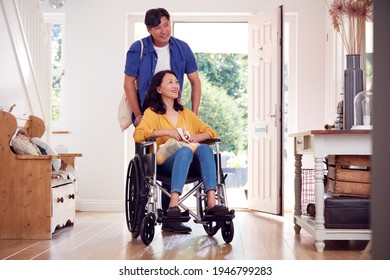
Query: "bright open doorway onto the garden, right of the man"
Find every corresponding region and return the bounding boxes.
[172,21,248,209]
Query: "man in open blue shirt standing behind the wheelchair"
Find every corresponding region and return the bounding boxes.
[124,8,201,233]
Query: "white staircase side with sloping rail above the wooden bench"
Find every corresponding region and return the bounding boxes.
[0,0,51,123]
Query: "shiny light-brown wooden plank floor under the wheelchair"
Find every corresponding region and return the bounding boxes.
[0,211,371,260]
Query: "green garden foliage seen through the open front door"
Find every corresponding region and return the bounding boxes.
[182,53,248,154]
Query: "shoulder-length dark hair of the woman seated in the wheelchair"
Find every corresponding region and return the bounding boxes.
[144,70,184,114]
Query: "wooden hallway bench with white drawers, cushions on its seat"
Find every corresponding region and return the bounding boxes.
[0,111,81,239]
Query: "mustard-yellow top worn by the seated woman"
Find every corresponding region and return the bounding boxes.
[133,108,218,149]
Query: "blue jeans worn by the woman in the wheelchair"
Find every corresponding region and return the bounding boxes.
[157,144,217,194]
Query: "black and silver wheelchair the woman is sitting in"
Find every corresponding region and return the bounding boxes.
[125,138,235,245]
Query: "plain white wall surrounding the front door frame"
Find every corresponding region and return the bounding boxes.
[28,0,325,211]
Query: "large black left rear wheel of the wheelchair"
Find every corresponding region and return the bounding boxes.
[125,156,146,238]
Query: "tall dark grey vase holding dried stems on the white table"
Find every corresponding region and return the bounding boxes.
[343,54,363,129]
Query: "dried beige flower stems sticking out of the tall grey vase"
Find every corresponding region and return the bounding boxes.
[325,0,373,54]
